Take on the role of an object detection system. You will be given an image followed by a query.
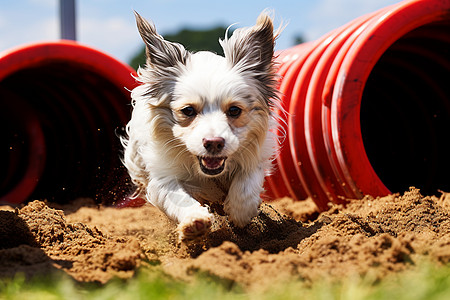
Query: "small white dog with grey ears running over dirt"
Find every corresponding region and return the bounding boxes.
[121,11,280,240]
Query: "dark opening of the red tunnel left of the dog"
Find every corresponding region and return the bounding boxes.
[0,61,130,203]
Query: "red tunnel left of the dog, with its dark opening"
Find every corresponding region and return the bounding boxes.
[0,41,136,203]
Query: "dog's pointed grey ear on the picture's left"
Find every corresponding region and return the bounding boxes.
[134,12,189,69]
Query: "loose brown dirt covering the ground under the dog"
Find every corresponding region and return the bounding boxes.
[0,188,450,289]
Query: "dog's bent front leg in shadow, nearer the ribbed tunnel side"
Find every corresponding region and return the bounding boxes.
[224,168,265,227]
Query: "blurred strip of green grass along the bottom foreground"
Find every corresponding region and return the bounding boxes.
[0,263,450,300]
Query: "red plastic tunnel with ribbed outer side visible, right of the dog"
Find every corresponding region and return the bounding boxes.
[267,0,450,210]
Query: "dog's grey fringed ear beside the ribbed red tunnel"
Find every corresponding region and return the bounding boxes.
[220,11,278,105]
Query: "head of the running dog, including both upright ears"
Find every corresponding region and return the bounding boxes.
[136,13,278,176]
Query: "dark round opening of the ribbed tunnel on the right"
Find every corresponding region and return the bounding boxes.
[360,21,450,195]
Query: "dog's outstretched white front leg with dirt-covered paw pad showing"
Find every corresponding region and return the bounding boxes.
[147,179,213,240]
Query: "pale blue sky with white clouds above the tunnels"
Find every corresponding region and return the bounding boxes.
[0,0,400,62]
